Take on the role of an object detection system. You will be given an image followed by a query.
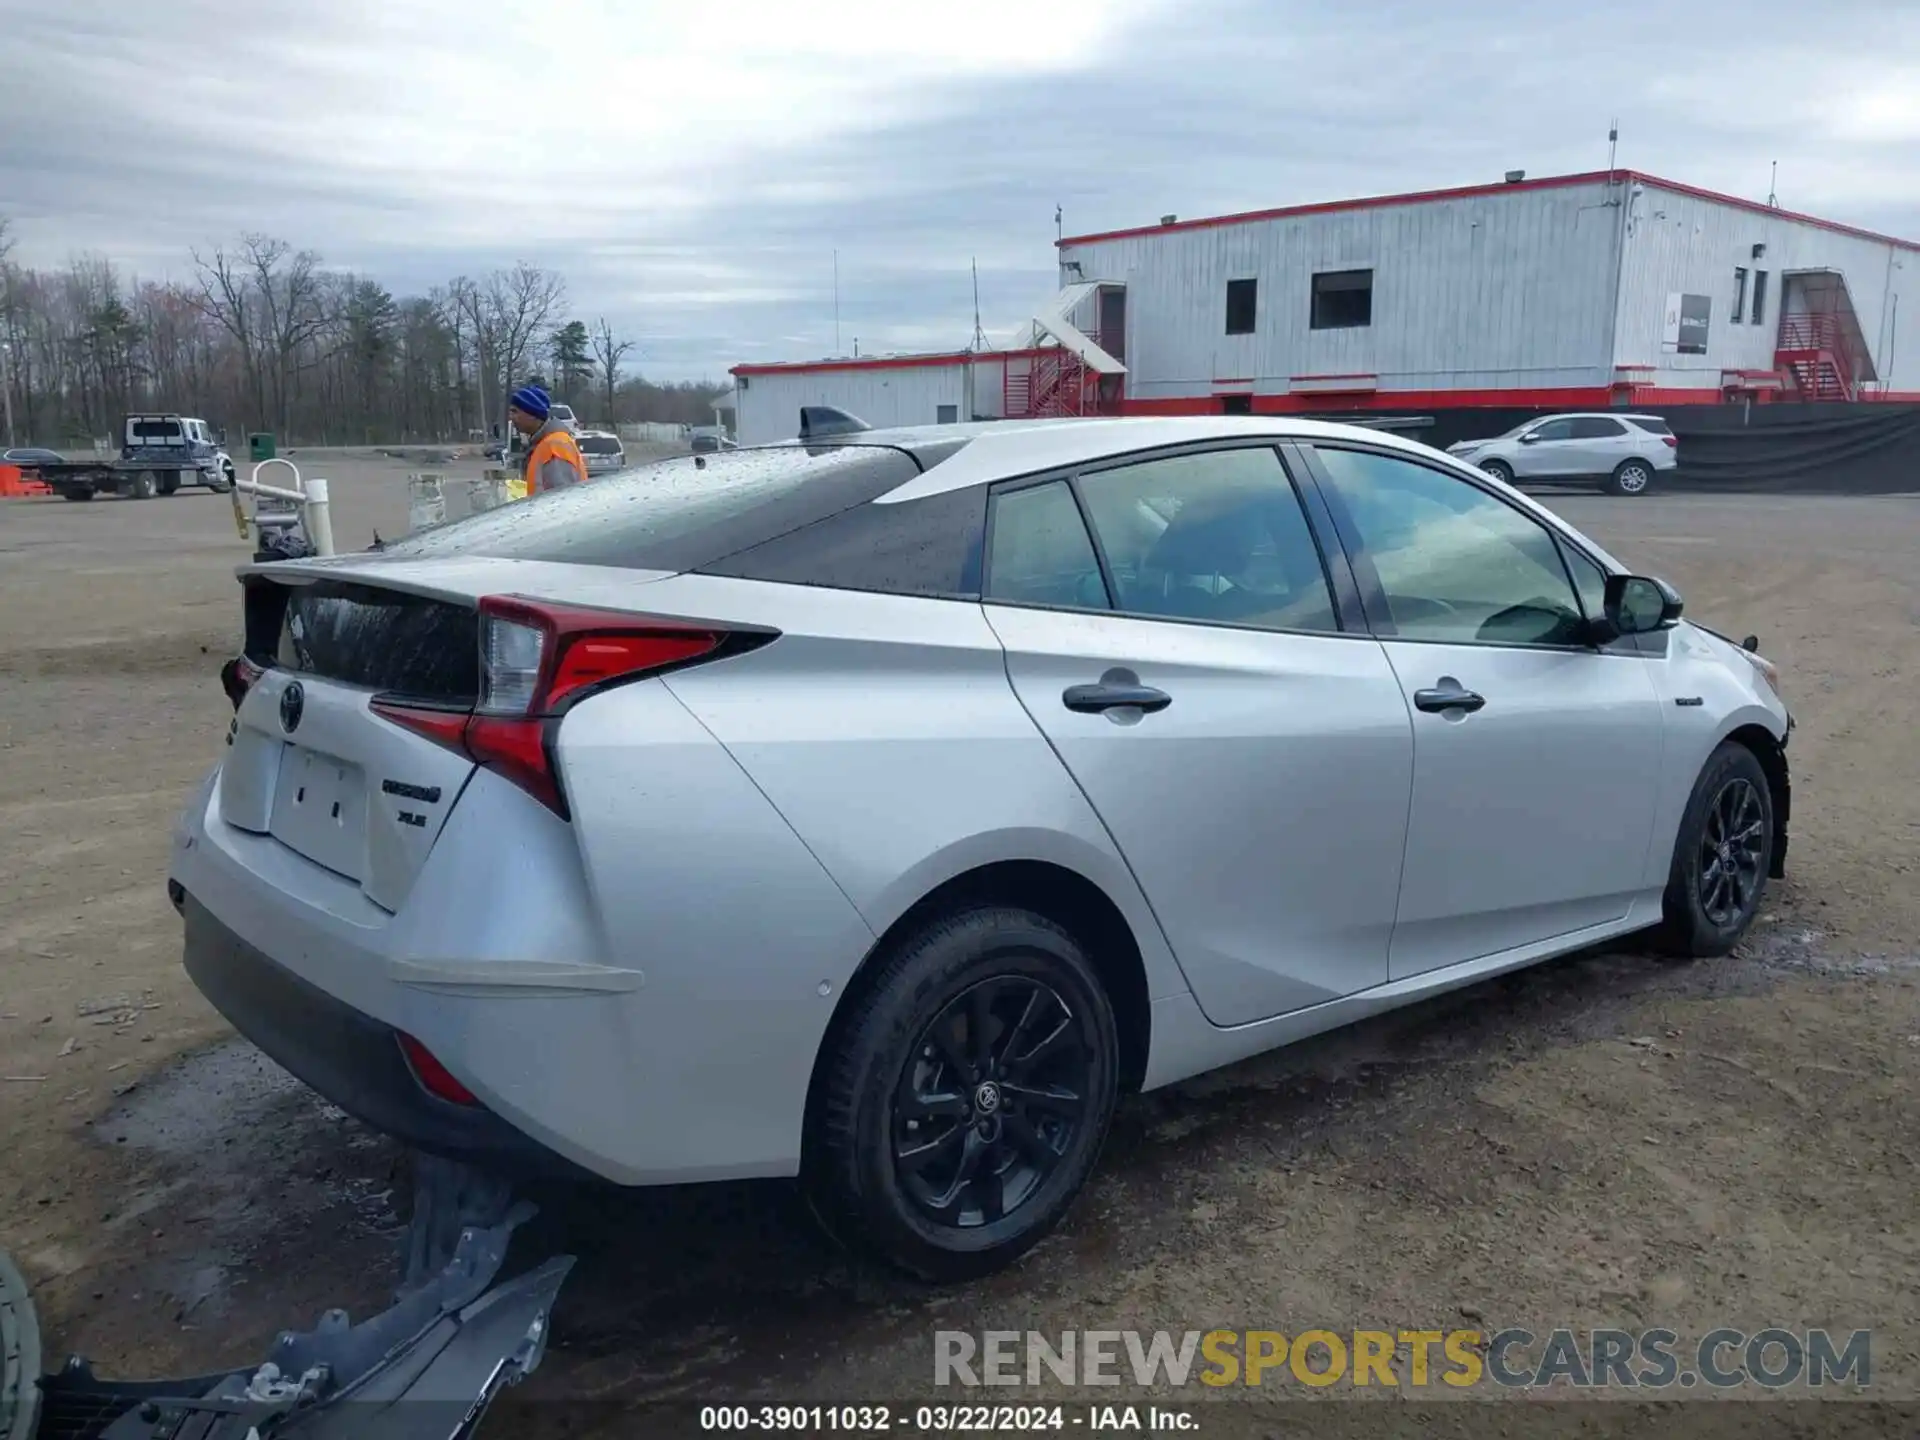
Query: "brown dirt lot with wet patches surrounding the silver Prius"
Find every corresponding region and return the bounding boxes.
[0,468,1920,1434]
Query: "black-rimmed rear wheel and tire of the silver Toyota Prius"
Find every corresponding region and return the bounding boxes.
[803,906,1119,1281]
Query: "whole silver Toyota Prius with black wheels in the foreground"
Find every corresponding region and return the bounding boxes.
[169,417,1791,1279]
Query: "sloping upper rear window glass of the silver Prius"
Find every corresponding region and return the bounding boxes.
[364,445,920,572]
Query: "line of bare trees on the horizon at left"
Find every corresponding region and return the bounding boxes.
[0,219,722,447]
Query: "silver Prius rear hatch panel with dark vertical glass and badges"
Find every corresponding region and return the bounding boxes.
[219,576,480,912]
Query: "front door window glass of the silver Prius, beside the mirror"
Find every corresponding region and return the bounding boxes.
[1319,447,1586,645]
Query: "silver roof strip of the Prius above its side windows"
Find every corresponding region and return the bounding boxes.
[783,415,1436,505]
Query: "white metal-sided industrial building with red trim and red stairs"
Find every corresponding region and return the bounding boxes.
[733,171,1920,444]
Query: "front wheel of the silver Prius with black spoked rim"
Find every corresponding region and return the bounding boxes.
[1659,739,1774,960]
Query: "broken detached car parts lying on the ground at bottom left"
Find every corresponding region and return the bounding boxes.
[0,1204,574,1440]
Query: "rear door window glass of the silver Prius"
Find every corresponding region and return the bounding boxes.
[1079,447,1340,632]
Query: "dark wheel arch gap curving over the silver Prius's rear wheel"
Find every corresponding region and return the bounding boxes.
[806,858,1152,1135]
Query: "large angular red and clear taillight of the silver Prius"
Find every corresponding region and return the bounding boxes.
[372,595,772,820]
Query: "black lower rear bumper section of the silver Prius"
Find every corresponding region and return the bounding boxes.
[175,889,588,1179]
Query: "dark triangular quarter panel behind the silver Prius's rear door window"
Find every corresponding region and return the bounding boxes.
[698,482,987,599]
